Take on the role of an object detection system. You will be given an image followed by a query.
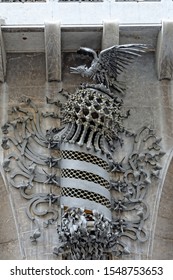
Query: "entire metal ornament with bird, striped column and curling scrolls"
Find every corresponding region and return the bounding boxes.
[2,44,164,260]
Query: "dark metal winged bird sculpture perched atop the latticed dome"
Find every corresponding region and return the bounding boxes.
[70,44,150,92]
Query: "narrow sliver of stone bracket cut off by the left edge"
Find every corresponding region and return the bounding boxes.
[0,25,6,82]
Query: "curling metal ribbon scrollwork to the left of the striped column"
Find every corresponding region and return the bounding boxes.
[2,97,61,242]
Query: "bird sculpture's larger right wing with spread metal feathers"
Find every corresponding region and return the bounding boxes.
[99,44,150,78]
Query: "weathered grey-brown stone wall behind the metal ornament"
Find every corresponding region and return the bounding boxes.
[0,25,173,259]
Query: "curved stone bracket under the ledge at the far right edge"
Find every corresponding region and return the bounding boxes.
[156,21,173,80]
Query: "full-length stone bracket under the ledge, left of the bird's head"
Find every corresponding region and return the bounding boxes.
[45,22,61,82]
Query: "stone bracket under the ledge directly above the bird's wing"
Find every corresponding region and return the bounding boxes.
[102,21,119,50]
